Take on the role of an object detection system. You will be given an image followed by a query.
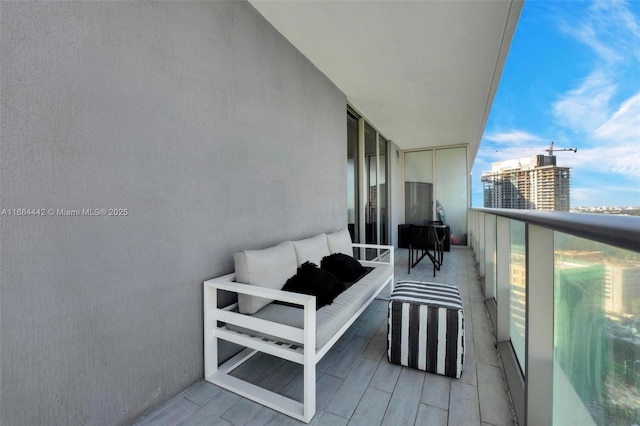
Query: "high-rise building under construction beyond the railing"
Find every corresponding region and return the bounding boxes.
[482,155,571,211]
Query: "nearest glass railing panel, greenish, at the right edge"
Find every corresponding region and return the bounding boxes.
[553,232,640,425]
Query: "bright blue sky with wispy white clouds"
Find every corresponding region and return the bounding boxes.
[472,0,640,207]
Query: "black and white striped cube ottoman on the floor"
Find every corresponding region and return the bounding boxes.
[387,281,464,378]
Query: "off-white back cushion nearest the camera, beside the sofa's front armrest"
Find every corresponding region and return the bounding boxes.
[233,241,298,314]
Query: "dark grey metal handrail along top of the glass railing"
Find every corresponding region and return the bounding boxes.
[471,208,640,252]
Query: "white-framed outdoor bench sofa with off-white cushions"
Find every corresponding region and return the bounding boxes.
[204,229,394,423]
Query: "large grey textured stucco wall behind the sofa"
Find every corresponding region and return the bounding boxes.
[0,2,346,426]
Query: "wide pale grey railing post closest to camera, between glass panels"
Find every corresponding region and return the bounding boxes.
[525,224,554,425]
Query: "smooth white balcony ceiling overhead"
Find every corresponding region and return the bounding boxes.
[249,0,523,163]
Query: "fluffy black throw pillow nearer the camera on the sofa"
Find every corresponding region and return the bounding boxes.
[282,262,345,310]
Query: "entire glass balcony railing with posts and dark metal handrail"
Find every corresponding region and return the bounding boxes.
[470,209,640,425]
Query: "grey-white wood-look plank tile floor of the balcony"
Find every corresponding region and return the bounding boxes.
[134,247,516,426]
